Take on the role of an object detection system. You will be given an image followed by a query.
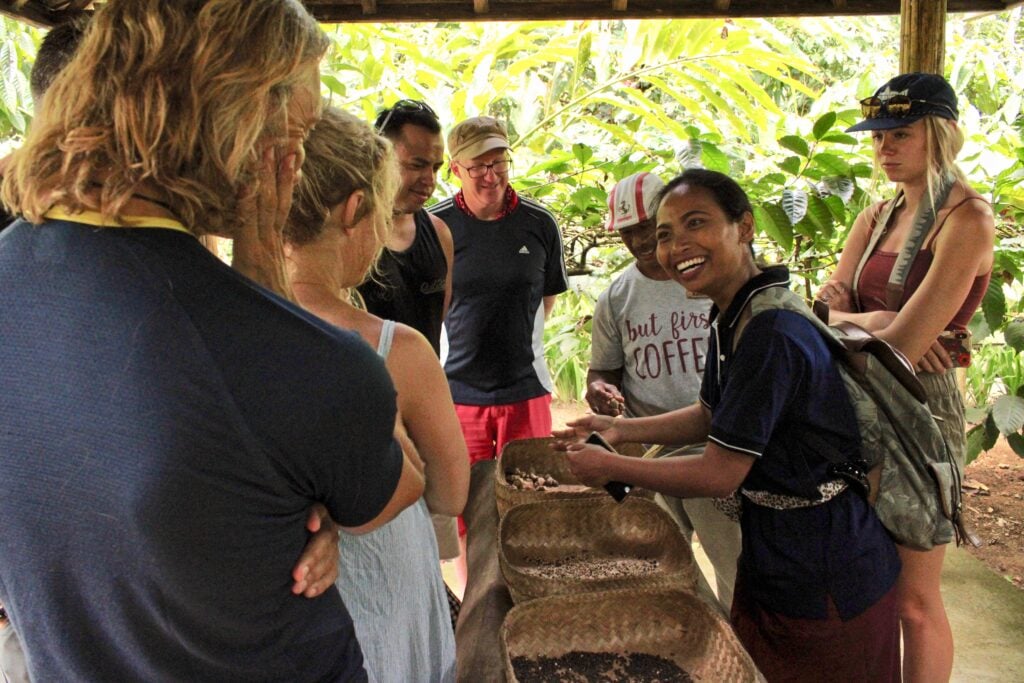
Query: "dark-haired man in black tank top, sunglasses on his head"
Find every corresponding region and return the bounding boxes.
[358,99,454,356]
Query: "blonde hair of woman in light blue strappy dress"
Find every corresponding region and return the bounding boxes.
[285,106,399,275]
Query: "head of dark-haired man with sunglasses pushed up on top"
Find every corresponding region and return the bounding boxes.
[374,99,444,213]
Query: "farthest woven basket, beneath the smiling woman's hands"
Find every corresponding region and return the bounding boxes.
[495,436,650,517]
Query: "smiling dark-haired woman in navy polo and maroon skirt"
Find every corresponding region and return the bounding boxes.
[563,170,900,682]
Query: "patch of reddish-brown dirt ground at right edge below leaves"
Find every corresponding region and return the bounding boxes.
[964,439,1024,589]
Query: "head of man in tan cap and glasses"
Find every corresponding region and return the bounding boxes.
[449,116,511,205]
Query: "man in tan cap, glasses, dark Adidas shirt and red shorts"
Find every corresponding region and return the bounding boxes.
[430,117,567,475]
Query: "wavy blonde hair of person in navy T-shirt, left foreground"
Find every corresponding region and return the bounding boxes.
[3,0,328,236]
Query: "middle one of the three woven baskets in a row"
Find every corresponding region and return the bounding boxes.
[498,496,696,603]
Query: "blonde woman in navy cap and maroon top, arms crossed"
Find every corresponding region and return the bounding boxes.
[818,74,995,681]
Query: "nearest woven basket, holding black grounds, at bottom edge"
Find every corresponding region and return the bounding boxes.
[502,590,765,683]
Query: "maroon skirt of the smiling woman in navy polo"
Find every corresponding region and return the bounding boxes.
[732,578,901,683]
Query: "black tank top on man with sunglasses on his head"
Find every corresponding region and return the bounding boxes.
[358,209,447,356]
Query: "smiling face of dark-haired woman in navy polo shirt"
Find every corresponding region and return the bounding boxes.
[655,184,757,308]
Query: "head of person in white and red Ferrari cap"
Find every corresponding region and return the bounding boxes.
[605,172,665,280]
